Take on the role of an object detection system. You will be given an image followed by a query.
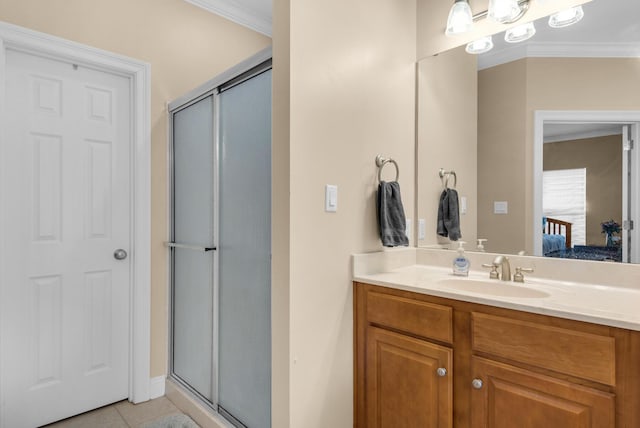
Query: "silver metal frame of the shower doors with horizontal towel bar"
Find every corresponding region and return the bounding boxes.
[166,48,272,426]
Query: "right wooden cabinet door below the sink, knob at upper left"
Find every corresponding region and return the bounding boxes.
[470,357,615,428]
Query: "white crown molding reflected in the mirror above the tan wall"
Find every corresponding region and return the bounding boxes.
[478,42,640,70]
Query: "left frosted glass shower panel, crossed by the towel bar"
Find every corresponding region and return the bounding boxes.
[172,97,214,401]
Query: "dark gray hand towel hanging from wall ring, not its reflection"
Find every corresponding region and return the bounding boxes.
[377,181,409,247]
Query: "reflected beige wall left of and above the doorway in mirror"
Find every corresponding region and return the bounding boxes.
[478,58,640,252]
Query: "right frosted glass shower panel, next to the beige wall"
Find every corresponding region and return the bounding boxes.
[219,71,271,428]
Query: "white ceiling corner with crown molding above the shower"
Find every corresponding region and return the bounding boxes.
[185,0,272,37]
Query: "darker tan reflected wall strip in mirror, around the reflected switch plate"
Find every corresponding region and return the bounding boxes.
[478,61,527,253]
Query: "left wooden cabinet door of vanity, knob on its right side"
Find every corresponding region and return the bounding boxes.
[365,327,453,428]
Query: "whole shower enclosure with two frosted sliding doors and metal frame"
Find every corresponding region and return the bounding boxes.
[168,50,271,428]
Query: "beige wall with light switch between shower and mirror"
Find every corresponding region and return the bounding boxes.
[273,0,416,428]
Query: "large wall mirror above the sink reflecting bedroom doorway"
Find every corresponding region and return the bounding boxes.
[416,0,640,263]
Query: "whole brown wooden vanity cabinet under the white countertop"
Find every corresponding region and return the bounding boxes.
[354,283,640,428]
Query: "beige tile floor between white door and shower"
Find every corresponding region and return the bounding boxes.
[46,397,190,428]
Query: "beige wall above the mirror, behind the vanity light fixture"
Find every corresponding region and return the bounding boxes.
[417,0,591,59]
